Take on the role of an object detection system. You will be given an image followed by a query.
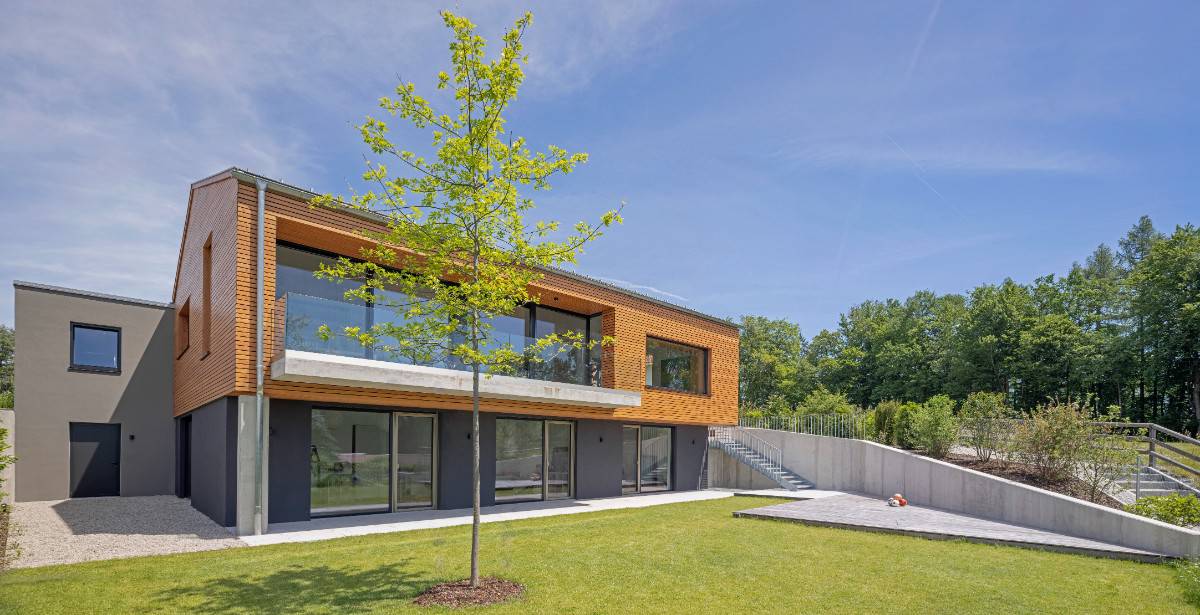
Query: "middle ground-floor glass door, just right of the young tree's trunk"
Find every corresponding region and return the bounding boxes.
[496,418,575,503]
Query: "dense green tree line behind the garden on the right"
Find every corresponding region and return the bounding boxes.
[739,216,1200,431]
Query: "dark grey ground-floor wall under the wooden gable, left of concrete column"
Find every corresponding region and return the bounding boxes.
[188,398,238,526]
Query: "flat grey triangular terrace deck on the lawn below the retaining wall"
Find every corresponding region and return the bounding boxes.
[733,494,1170,562]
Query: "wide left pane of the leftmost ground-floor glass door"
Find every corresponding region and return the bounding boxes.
[308,408,391,515]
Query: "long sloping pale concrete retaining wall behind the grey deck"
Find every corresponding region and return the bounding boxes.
[750,429,1200,557]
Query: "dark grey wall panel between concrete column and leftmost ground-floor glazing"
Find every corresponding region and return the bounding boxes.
[266,399,312,524]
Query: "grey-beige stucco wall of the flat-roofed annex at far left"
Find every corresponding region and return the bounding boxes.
[14,283,175,501]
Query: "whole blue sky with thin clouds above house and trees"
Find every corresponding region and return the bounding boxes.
[0,0,1200,336]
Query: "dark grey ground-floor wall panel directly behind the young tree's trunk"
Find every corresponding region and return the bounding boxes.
[438,411,496,509]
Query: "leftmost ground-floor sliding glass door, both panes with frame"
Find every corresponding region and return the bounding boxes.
[308,408,437,517]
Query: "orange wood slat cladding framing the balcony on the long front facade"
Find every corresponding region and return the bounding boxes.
[176,175,738,424]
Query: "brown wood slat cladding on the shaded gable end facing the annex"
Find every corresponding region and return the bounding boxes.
[172,177,238,416]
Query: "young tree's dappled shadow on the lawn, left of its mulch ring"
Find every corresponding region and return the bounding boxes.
[158,560,433,613]
